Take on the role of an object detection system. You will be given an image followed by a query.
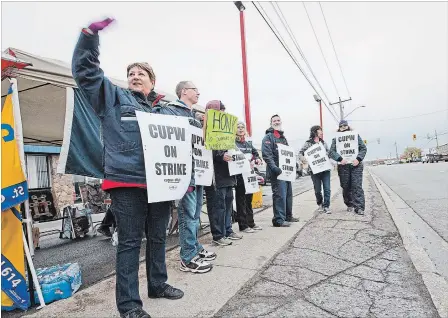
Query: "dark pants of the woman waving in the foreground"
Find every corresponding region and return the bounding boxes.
[110,188,171,314]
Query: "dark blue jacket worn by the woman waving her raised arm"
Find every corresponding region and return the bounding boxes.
[72,33,164,184]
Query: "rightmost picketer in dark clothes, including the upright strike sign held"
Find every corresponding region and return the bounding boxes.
[330,120,367,215]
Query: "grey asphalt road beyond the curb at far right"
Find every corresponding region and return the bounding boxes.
[371,162,448,281]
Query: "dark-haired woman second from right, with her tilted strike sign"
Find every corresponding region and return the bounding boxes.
[299,126,338,214]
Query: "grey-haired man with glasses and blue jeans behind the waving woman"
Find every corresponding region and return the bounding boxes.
[154,81,216,273]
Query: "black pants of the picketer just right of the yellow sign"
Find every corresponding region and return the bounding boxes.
[235,178,255,231]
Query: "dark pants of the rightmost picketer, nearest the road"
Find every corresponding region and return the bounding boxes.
[338,163,366,211]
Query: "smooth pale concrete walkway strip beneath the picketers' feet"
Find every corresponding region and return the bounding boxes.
[26,173,339,317]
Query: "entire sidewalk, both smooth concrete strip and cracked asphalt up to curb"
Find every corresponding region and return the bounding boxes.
[24,172,438,317]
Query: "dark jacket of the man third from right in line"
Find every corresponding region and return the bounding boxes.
[261,127,288,178]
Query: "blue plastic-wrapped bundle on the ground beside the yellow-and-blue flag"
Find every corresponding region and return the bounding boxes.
[34,263,82,303]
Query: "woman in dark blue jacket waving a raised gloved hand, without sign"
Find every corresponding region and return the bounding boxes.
[72,18,184,318]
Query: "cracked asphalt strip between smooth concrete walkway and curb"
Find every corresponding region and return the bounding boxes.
[215,173,439,317]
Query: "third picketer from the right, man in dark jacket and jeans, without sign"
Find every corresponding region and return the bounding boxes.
[261,115,299,227]
